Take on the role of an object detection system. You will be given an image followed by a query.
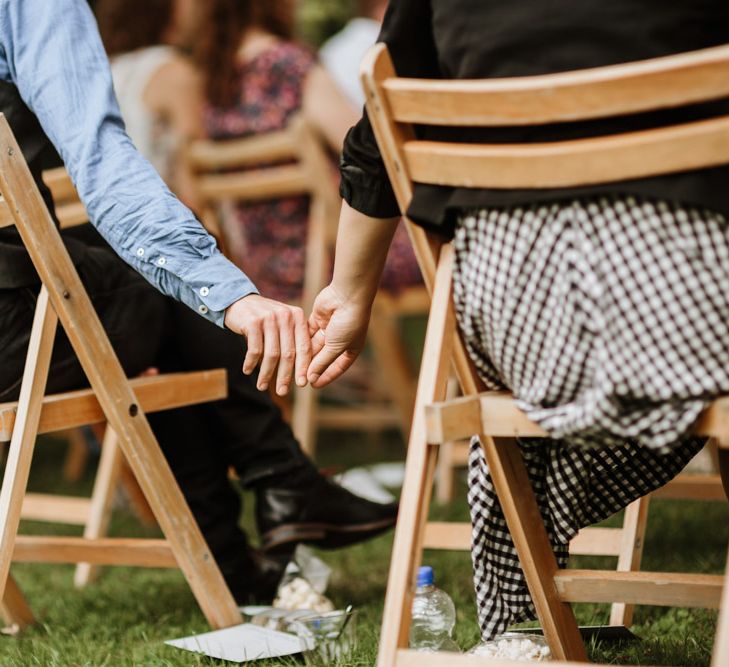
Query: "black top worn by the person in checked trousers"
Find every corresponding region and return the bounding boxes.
[340,0,729,235]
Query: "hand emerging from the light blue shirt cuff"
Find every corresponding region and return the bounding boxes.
[225,294,311,396]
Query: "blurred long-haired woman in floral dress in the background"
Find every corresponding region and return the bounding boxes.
[194,0,357,303]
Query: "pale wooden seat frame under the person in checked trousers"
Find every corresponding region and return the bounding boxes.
[425,392,729,446]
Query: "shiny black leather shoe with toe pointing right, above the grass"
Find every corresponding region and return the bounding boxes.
[256,472,397,555]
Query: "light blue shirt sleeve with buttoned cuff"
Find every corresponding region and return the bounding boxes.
[0,0,257,326]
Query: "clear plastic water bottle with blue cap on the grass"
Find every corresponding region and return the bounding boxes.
[410,566,460,652]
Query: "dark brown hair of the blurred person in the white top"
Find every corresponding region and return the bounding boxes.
[96,0,173,57]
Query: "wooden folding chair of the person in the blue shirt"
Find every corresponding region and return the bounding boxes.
[0,116,241,628]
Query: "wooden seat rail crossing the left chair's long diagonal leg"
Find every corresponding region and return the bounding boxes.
[0,369,227,441]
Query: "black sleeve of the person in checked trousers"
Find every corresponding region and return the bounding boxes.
[339,0,440,218]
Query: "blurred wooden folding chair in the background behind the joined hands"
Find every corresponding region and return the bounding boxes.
[186,116,427,455]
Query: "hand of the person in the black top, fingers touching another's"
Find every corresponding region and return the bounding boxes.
[308,285,370,388]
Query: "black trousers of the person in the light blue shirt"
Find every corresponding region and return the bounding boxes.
[0,237,311,581]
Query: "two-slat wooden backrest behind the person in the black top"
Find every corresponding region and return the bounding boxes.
[362,44,729,194]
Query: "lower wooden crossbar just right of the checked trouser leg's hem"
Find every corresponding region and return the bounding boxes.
[555,570,723,609]
